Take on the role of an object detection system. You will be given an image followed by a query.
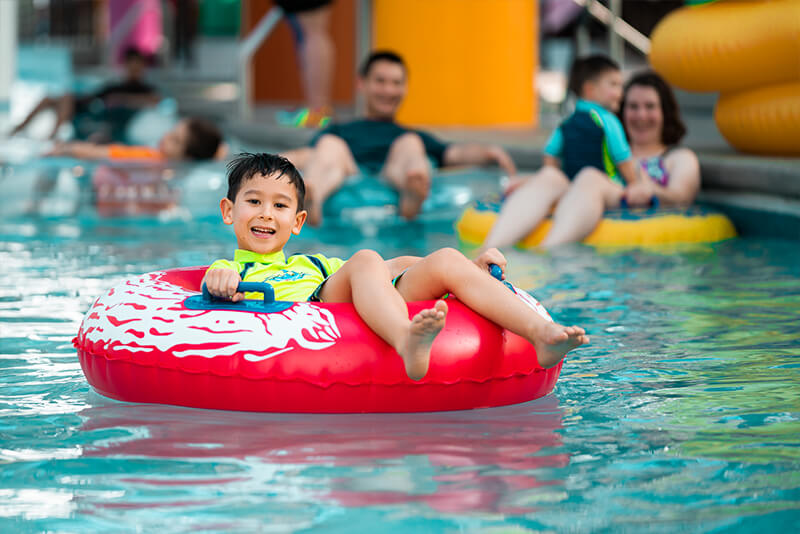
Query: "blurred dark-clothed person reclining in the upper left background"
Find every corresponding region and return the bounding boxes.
[11,48,161,141]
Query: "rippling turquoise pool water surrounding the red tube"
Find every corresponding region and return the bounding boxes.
[0,175,800,533]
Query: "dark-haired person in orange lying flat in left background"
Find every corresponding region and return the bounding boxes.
[48,117,223,162]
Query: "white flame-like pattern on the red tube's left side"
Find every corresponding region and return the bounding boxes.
[79,272,341,361]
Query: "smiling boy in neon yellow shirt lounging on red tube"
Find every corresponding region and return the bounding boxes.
[203,154,589,380]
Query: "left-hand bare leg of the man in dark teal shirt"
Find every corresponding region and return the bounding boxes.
[303,134,358,226]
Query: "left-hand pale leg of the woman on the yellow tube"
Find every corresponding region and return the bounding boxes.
[483,165,569,249]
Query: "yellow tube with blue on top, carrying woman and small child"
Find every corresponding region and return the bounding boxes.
[456,202,736,248]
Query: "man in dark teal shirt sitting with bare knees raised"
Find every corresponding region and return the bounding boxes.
[284,51,516,225]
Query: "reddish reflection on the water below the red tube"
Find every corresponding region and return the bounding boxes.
[73,395,569,513]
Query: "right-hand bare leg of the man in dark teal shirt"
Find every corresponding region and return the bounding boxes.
[382,132,431,219]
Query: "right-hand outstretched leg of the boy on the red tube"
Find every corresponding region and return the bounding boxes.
[397,248,589,368]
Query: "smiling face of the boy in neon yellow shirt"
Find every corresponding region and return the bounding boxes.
[220,174,307,254]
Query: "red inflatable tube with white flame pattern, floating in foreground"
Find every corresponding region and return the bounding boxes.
[73,267,561,413]
